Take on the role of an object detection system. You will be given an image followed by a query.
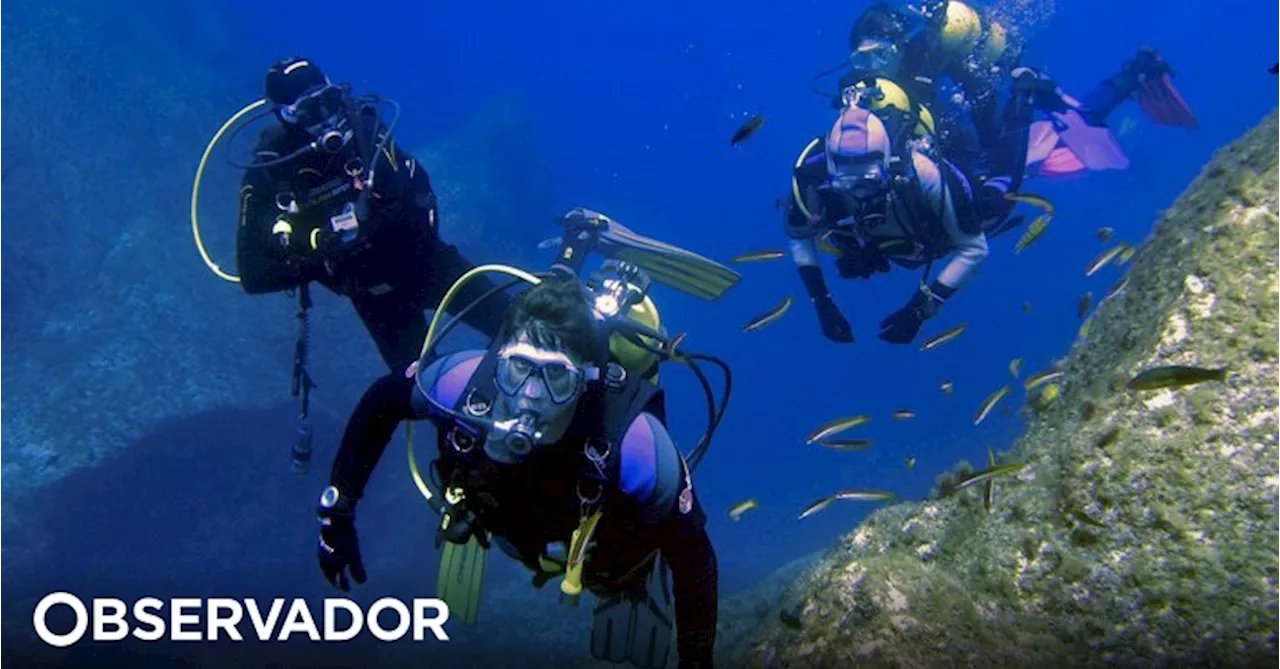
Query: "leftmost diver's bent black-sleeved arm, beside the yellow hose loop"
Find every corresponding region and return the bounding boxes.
[236,169,310,294]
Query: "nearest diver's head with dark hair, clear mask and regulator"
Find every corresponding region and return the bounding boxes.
[485,275,600,463]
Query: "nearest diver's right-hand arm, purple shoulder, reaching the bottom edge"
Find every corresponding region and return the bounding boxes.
[620,413,719,668]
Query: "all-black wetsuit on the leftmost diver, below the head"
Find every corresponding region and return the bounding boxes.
[236,120,509,372]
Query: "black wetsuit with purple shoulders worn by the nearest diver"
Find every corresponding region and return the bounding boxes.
[330,360,718,669]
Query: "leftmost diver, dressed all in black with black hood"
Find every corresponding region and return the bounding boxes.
[236,58,507,372]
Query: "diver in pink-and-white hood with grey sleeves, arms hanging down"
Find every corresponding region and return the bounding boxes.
[785,105,1011,344]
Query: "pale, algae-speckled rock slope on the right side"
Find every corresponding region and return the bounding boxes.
[732,113,1280,668]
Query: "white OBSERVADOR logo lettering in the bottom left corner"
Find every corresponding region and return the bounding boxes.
[32,592,449,647]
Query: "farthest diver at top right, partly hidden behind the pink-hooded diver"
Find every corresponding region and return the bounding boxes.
[814,0,1196,178]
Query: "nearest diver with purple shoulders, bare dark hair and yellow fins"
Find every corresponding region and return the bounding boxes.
[317,209,741,669]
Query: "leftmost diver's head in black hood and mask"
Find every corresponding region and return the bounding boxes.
[265,56,348,148]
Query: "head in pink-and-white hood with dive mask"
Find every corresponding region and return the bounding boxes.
[826,106,892,225]
